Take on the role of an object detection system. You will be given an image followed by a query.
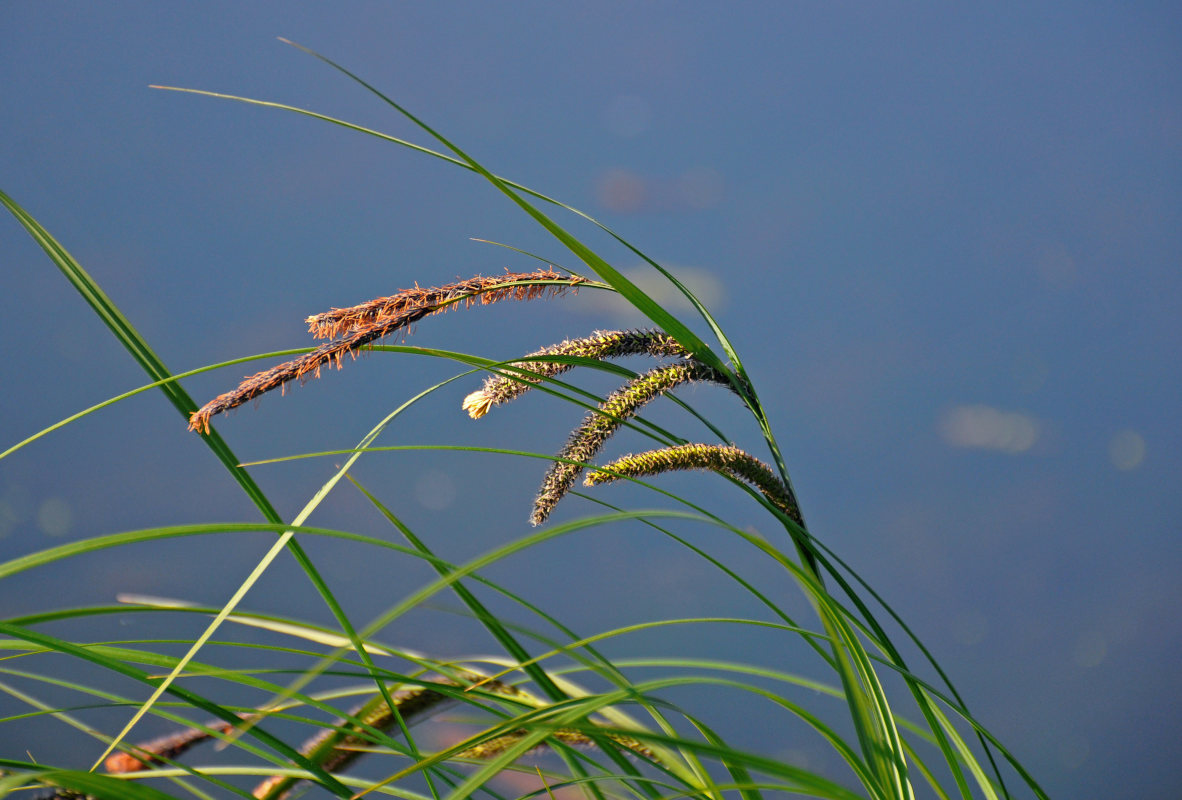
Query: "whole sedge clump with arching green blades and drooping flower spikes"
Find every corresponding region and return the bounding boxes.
[0,37,1045,800]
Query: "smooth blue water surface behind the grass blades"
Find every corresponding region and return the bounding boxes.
[0,2,1182,798]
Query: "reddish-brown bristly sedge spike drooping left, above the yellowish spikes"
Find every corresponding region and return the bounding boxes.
[189,269,586,434]
